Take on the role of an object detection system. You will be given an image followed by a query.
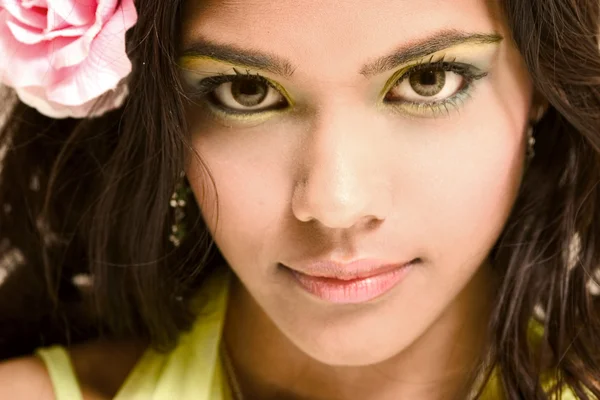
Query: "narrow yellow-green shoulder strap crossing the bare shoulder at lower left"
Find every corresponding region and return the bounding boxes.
[35,346,83,400]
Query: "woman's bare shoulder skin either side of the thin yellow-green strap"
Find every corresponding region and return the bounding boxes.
[0,342,146,400]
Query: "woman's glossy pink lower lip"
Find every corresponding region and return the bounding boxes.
[290,264,411,304]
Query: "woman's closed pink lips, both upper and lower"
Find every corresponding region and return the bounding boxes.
[290,260,412,304]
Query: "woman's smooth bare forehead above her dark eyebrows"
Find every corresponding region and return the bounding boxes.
[181,0,506,74]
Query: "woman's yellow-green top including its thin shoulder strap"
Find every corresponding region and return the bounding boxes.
[36,273,576,400]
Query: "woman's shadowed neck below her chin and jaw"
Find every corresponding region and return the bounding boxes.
[224,264,493,400]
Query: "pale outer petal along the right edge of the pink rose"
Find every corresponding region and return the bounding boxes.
[47,0,137,105]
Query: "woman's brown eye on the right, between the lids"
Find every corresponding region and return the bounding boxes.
[385,68,466,103]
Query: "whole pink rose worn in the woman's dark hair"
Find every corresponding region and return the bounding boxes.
[0,0,137,118]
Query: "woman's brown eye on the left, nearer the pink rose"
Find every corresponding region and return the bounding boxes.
[212,76,287,112]
